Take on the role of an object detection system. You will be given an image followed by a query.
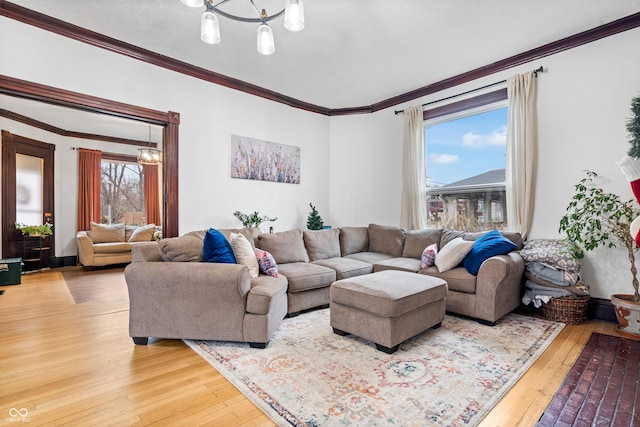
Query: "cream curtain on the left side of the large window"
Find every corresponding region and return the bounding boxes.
[400,106,427,230]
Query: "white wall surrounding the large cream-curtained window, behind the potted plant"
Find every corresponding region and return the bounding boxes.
[331,29,640,298]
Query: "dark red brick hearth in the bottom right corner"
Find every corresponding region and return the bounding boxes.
[537,332,640,427]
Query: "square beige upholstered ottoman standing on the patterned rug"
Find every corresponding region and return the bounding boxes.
[329,270,447,354]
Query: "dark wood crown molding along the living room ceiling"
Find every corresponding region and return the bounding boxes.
[0,0,640,116]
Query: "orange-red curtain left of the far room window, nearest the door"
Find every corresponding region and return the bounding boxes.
[78,148,102,231]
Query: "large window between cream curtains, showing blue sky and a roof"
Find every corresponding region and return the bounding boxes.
[425,91,507,231]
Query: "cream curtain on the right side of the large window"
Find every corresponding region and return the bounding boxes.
[506,72,538,239]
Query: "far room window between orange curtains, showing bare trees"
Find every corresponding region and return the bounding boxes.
[100,153,146,225]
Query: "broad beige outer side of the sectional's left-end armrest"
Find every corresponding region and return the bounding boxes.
[124,262,251,341]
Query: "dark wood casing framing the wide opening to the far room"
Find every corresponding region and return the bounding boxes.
[0,75,180,237]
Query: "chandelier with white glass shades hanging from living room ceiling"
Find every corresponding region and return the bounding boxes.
[180,0,304,55]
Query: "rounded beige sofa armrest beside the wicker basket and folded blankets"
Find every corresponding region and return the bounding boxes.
[476,251,524,322]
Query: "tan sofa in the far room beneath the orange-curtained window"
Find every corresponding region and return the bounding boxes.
[76,223,159,267]
